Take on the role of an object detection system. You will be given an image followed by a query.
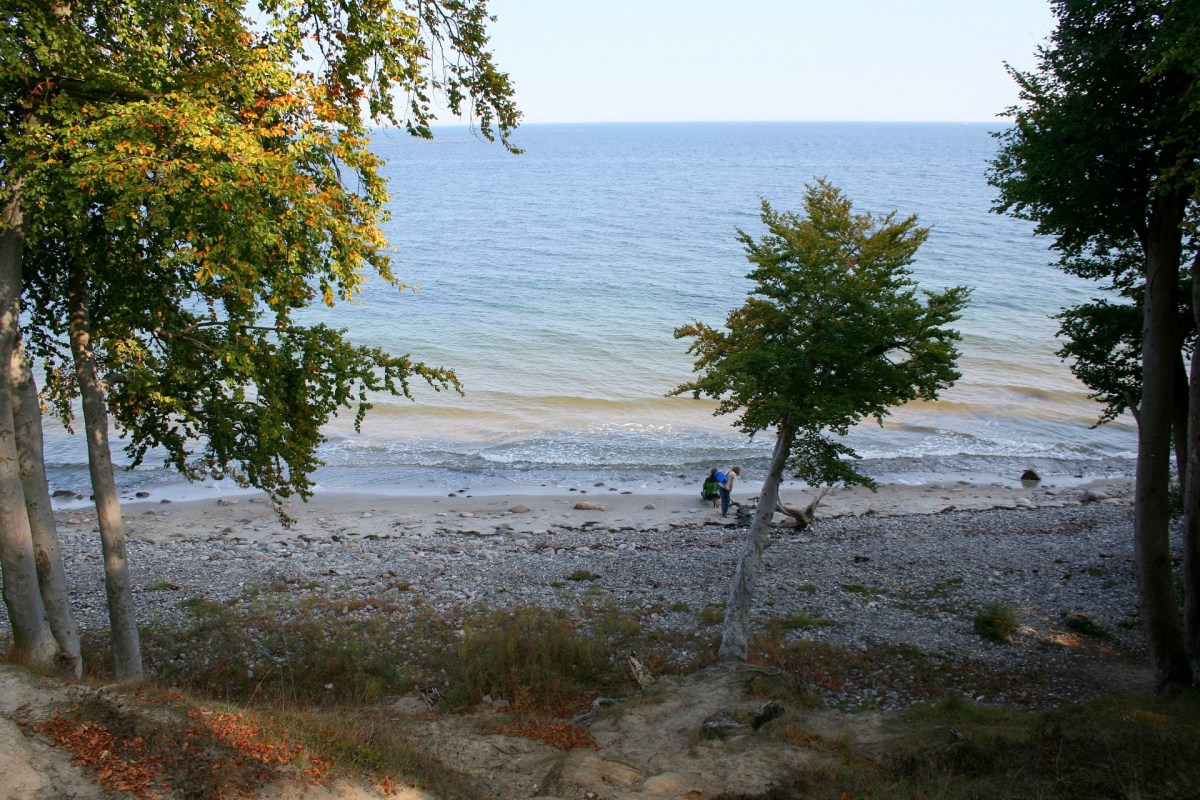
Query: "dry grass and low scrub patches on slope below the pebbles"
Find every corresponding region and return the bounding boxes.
[64,589,1200,800]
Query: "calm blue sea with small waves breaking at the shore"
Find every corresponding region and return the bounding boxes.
[47,122,1135,498]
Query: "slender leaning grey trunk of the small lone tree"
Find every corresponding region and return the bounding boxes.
[718,425,796,661]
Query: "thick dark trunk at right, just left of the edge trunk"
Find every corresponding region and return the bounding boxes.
[1134,206,1190,688]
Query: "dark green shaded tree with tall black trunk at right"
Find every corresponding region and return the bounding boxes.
[989,0,1200,686]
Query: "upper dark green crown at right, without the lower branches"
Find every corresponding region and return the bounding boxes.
[989,0,1200,253]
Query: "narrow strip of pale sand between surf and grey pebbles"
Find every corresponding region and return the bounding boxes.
[82,477,1133,541]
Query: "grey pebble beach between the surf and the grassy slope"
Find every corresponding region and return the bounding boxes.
[30,479,1151,705]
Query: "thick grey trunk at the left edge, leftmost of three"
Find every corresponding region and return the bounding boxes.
[0,190,58,672]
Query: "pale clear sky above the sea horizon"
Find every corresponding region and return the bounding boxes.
[488,0,1054,124]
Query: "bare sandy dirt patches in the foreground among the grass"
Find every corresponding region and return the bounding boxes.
[0,647,1148,800]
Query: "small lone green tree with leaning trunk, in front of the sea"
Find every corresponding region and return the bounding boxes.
[672,181,968,660]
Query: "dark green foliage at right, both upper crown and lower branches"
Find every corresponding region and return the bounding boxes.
[989,0,1200,423]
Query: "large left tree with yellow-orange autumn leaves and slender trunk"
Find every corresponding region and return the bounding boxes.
[0,0,518,678]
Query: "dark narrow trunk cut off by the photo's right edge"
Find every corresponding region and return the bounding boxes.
[1183,254,1200,686]
